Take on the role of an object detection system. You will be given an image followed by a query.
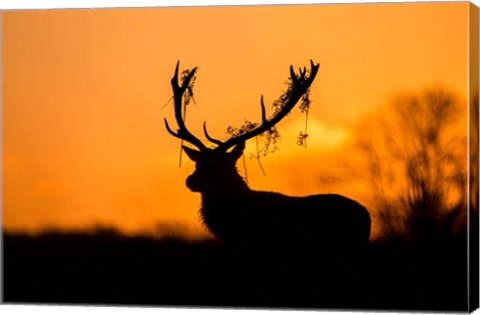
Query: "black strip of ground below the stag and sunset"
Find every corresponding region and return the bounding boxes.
[3,230,467,311]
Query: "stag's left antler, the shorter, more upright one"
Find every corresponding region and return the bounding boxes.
[164,61,207,151]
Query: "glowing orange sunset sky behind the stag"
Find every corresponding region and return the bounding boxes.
[1,2,470,237]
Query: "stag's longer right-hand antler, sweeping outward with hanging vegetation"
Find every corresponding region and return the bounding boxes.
[208,60,320,150]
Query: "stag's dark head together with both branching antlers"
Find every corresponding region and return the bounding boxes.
[165,61,320,193]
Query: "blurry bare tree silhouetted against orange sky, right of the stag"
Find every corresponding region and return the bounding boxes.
[357,87,467,240]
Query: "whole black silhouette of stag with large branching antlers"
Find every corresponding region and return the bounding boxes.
[165,61,371,249]
